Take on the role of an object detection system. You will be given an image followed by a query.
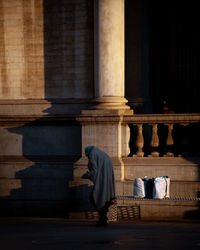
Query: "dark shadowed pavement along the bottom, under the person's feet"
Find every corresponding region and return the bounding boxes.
[0,218,200,250]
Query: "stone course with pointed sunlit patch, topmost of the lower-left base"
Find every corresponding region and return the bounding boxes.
[0,156,73,180]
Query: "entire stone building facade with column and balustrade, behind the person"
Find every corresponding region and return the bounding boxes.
[0,0,200,217]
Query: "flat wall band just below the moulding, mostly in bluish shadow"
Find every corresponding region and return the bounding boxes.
[0,122,80,156]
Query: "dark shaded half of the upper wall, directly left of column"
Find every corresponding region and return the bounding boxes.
[44,0,93,98]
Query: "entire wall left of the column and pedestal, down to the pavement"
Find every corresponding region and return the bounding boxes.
[0,0,93,216]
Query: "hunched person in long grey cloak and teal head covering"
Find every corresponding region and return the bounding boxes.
[82,146,115,226]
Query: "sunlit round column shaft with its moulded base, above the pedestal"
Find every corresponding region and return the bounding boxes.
[94,0,129,109]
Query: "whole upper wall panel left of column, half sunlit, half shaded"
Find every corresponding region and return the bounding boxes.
[0,0,93,99]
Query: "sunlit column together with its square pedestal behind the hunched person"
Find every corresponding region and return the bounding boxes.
[70,0,133,216]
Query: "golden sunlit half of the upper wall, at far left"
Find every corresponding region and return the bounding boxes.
[0,0,44,99]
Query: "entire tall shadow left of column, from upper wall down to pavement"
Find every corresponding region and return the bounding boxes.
[0,0,93,217]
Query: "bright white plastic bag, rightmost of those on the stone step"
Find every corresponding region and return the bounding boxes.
[153,176,170,199]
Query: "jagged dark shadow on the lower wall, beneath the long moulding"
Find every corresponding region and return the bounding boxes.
[0,108,81,217]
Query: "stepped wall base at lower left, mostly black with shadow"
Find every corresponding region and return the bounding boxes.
[0,156,77,217]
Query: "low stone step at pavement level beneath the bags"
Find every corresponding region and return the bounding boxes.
[69,196,200,221]
